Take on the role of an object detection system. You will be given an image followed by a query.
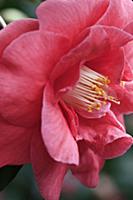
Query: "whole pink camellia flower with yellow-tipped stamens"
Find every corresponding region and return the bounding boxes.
[0,0,133,200]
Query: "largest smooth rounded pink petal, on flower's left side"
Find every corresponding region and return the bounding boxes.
[0,31,69,126]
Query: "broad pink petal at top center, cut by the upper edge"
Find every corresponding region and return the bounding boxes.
[37,0,108,40]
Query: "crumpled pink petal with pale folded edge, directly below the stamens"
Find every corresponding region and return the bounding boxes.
[77,111,125,143]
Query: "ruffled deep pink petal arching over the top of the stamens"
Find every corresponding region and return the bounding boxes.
[51,26,133,91]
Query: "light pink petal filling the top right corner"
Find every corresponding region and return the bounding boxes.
[98,0,133,28]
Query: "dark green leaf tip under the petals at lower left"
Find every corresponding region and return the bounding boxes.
[0,165,22,191]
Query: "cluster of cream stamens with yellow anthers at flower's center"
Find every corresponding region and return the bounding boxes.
[63,66,120,112]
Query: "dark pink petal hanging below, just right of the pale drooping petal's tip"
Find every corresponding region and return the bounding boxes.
[72,142,104,187]
